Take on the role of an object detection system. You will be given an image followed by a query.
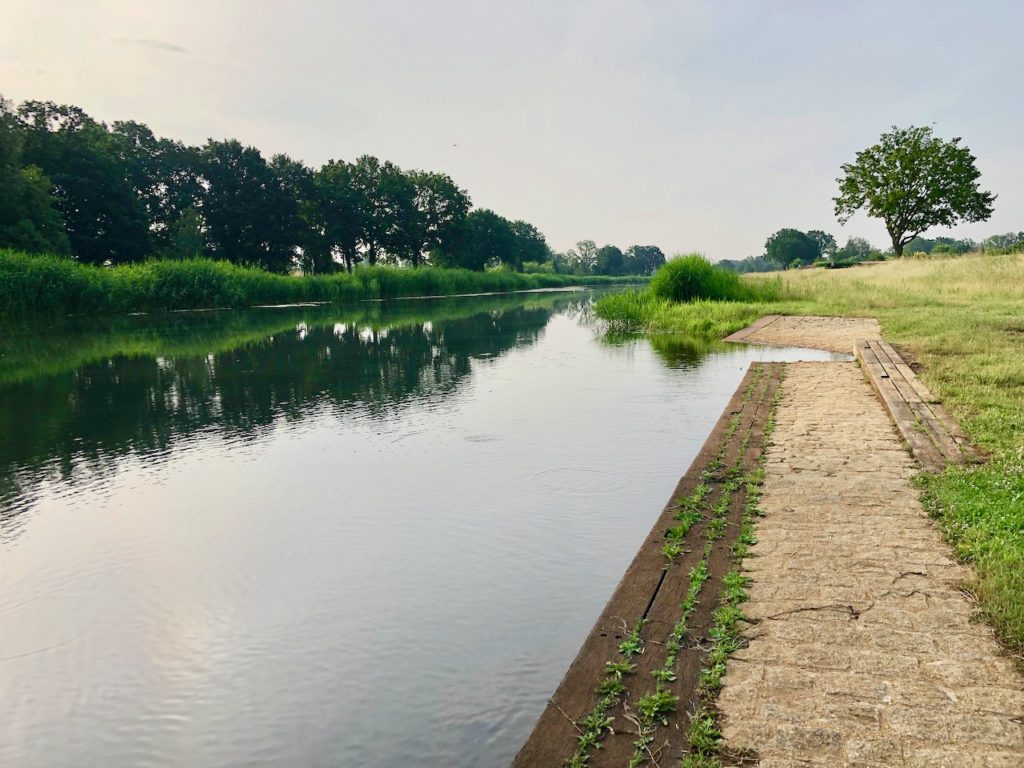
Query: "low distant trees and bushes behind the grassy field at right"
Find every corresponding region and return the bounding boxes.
[718,229,1024,272]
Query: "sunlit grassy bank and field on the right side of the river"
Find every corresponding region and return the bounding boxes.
[597,254,1024,651]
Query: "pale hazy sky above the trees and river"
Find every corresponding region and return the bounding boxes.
[0,0,1024,260]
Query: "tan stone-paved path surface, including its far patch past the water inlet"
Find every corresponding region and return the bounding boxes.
[719,360,1024,768]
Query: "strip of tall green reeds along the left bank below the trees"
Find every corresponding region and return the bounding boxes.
[0,251,643,317]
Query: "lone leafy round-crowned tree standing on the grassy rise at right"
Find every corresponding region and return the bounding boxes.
[833,126,995,256]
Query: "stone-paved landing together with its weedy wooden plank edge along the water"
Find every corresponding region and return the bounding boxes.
[516,316,1024,768]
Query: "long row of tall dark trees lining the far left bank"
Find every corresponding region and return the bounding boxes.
[0,98,665,275]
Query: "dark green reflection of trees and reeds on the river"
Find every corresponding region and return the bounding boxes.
[0,293,577,532]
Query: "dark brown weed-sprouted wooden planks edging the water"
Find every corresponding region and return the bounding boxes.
[513,364,782,768]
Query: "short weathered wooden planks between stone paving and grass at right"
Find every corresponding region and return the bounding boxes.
[854,340,982,472]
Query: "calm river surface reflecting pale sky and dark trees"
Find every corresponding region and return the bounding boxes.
[0,293,829,767]
